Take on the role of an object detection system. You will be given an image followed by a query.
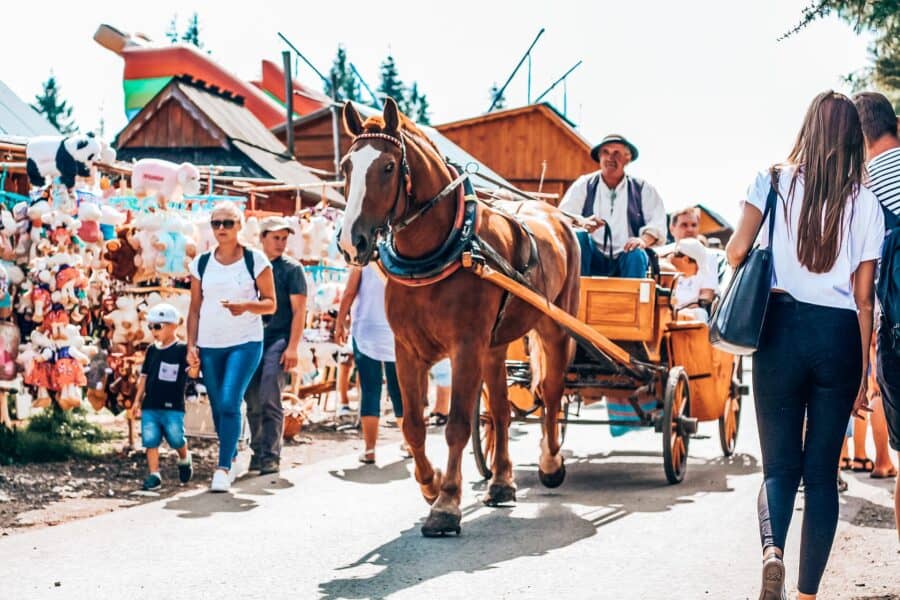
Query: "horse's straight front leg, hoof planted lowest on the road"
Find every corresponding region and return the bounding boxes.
[422,346,485,537]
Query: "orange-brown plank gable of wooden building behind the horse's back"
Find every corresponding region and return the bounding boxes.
[437,103,599,197]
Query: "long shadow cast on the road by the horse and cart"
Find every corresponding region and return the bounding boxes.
[319,452,760,599]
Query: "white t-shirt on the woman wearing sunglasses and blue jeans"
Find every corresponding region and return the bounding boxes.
[190,249,272,348]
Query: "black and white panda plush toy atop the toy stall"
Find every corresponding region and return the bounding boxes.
[25,133,103,188]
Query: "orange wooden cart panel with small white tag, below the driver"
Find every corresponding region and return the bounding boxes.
[578,277,656,342]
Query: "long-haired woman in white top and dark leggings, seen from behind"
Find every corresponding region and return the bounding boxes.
[727,91,884,600]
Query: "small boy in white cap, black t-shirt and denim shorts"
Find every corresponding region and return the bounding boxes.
[131,303,194,490]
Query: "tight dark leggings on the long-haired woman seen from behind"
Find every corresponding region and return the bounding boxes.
[753,294,862,594]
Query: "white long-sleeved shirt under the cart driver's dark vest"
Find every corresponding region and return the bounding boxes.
[559,171,666,255]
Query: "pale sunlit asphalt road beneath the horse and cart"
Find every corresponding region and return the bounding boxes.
[0,386,900,600]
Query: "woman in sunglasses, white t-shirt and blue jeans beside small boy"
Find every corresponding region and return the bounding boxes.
[187,202,276,492]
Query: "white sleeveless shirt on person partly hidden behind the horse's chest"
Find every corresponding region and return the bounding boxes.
[350,264,395,362]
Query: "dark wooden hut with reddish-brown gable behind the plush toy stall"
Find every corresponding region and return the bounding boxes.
[114,78,343,214]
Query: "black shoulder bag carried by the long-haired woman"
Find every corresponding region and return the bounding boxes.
[709,170,778,355]
